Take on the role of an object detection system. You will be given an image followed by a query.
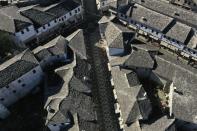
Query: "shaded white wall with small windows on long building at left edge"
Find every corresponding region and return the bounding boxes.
[0,66,43,107]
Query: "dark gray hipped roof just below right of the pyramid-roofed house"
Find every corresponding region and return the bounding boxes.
[124,50,154,69]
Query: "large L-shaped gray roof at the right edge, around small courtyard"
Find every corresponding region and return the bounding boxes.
[154,55,197,123]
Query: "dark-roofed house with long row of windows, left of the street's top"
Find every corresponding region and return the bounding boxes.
[21,0,83,44]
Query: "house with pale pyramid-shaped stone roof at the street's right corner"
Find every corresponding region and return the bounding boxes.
[99,16,135,56]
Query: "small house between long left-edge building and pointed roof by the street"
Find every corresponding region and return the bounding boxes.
[33,36,73,70]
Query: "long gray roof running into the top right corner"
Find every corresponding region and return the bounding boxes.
[133,0,197,28]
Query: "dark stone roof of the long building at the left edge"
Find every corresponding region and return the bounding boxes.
[0,50,39,88]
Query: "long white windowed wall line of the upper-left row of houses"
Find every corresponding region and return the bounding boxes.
[13,6,83,47]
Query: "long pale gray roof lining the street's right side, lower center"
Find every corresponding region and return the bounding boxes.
[112,66,141,123]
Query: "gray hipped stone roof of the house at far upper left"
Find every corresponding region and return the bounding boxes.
[0,6,32,33]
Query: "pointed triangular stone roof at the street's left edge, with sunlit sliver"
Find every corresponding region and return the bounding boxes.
[66,29,87,59]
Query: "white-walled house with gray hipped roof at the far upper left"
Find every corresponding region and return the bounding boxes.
[0,6,36,47]
